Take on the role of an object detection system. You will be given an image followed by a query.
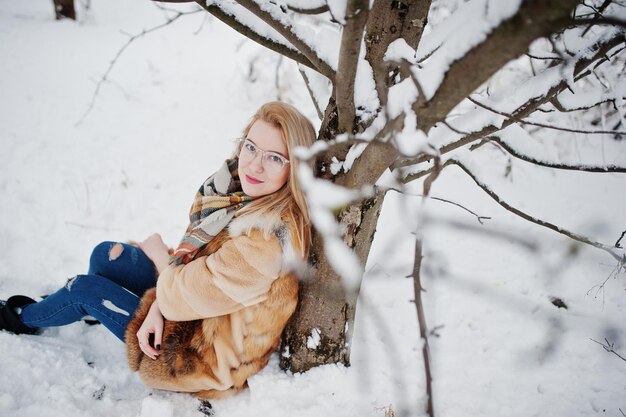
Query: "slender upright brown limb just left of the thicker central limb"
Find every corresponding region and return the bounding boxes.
[335,0,369,133]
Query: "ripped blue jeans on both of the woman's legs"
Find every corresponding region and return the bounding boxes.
[20,242,157,341]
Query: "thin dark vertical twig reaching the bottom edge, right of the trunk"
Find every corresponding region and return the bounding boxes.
[412,232,435,417]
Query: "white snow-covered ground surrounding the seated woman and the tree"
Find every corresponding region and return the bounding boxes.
[0,0,626,417]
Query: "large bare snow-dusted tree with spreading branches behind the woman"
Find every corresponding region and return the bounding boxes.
[154,0,626,371]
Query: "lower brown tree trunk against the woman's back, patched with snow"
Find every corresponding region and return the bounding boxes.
[280,188,384,372]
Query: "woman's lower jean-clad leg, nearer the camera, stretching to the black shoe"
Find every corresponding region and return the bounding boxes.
[20,275,140,341]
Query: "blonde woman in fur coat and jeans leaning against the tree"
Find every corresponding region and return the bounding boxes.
[0,102,315,398]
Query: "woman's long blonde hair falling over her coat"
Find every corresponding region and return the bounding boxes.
[235,101,315,258]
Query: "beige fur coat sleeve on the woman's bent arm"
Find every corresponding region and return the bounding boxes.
[157,230,282,321]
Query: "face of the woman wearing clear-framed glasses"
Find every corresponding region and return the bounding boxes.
[239,120,289,197]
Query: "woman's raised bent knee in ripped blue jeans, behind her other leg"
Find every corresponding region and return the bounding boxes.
[88,242,157,296]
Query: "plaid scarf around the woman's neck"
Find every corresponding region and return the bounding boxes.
[170,158,253,265]
